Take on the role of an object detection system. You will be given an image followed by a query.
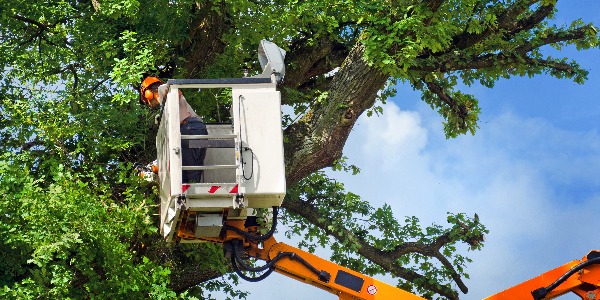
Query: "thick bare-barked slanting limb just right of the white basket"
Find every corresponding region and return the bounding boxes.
[285,39,388,186]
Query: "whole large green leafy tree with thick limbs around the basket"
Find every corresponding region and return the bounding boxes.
[0,0,598,299]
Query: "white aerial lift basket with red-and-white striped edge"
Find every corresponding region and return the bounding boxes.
[156,75,285,241]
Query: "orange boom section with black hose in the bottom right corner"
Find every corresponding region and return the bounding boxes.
[485,251,600,300]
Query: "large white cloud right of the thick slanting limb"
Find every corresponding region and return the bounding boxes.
[336,102,600,299]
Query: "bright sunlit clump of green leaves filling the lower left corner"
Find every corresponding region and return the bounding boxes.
[0,154,172,299]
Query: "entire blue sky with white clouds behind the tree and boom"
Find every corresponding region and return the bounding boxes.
[220,0,600,300]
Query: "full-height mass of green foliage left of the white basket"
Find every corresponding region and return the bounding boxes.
[0,1,233,299]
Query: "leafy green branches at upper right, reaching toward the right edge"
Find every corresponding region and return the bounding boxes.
[359,0,599,138]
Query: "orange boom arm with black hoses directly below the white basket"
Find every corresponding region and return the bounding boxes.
[223,209,424,300]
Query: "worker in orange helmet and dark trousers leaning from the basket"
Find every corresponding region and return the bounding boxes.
[140,76,208,183]
